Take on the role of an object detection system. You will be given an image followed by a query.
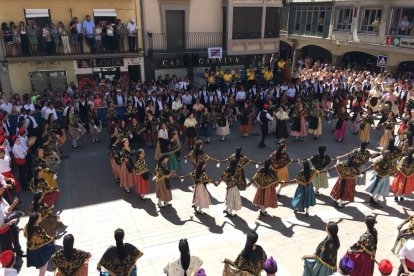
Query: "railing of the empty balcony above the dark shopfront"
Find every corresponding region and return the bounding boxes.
[147,32,225,52]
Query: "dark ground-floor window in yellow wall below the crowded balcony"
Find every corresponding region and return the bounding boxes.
[29,71,67,95]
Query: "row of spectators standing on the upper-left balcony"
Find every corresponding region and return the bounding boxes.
[1,15,138,56]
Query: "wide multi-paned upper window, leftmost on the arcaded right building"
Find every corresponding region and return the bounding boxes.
[288,6,332,38]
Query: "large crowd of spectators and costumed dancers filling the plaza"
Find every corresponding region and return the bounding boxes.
[0,54,414,276]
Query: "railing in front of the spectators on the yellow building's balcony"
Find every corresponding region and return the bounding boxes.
[1,30,142,58]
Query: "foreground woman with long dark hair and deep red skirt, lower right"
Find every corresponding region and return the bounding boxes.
[347,215,378,276]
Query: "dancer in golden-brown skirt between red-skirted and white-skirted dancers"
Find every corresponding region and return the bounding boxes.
[155,154,173,208]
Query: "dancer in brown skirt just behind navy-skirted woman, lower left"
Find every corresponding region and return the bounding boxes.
[29,192,67,237]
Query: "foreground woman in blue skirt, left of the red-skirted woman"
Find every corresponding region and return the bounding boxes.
[302,221,341,276]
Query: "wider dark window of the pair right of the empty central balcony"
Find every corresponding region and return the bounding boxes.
[233,7,262,39]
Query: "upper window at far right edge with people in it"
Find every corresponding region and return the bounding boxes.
[388,8,414,36]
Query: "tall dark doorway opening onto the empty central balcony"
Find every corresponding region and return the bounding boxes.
[165,10,185,50]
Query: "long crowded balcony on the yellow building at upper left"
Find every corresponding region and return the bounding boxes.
[1,30,143,61]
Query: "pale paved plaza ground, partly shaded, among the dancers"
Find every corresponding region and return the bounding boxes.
[15,123,414,276]
